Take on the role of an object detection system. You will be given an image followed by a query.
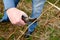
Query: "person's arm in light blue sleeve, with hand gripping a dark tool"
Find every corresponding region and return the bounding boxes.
[3,0,27,26]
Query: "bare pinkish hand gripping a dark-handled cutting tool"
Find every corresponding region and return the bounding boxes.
[7,8,28,26]
